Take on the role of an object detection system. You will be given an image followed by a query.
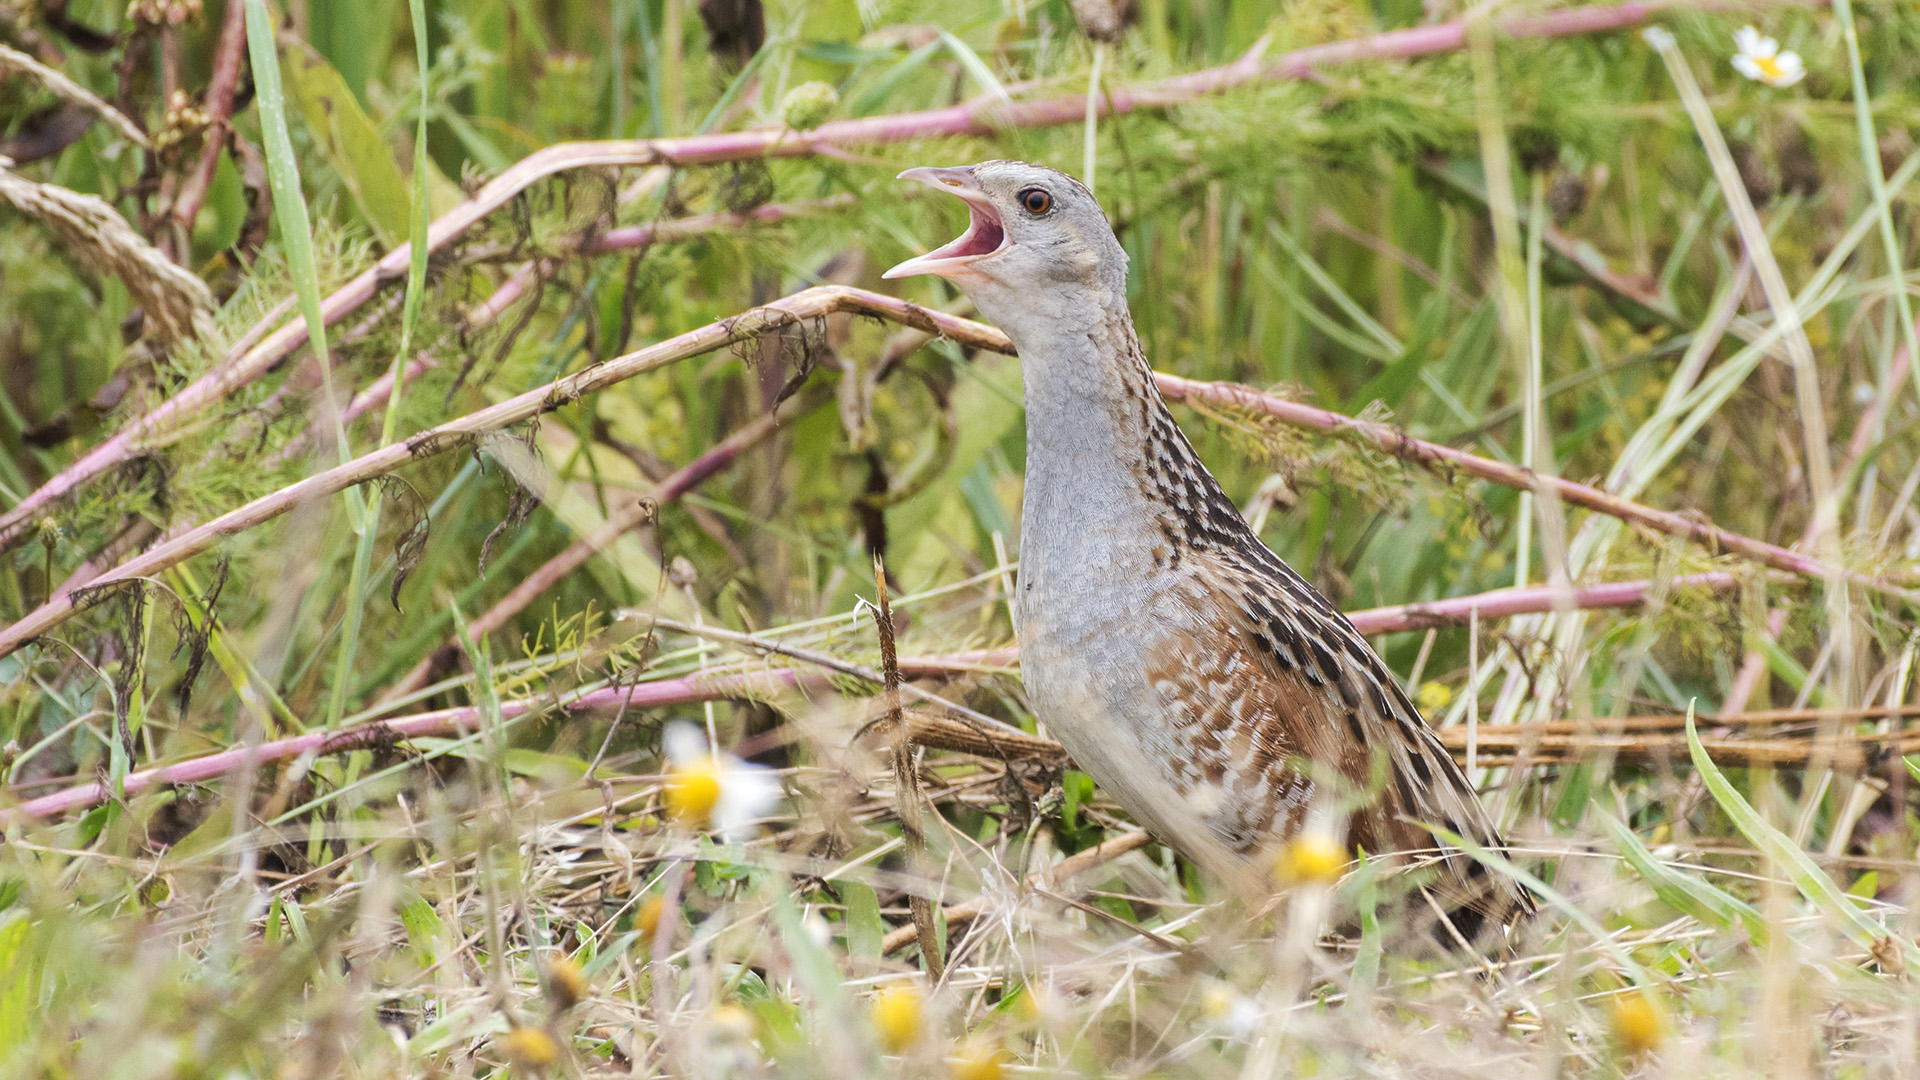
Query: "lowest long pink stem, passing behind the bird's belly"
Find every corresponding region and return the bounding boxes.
[0,568,1736,826]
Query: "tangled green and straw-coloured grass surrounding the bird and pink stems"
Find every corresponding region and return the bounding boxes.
[0,0,1920,1080]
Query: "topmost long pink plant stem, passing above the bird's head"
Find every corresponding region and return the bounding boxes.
[0,0,1704,552]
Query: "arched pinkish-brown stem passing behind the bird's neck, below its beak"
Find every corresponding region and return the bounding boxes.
[0,284,1896,655]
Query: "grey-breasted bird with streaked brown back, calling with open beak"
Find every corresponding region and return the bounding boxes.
[883,161,1534,951]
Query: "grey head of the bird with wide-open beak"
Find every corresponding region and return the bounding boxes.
[883,161,1127,319]
